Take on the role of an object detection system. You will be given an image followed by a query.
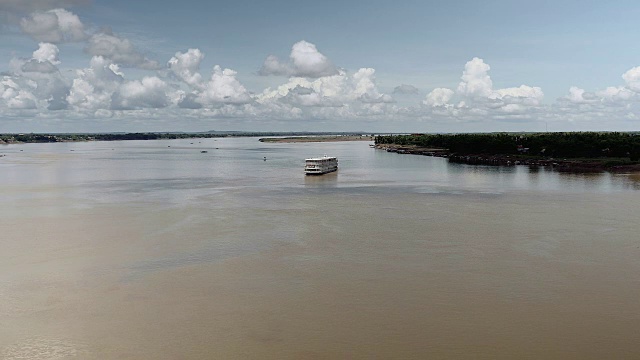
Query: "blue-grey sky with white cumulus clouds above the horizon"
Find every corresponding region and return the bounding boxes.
[0,0,640,132]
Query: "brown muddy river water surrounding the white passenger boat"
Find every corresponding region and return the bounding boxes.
[0,139,640,359]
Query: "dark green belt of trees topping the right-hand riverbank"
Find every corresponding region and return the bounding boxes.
[375,132,640,162]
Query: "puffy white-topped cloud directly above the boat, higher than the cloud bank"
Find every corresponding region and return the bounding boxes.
[258,40,338,78]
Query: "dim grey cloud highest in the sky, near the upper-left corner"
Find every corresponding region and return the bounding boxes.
[20,9,88,43]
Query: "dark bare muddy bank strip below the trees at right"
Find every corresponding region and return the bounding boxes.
[375,144,640,173]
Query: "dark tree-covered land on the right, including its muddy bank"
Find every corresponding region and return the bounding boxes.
[375,132,640,173]
